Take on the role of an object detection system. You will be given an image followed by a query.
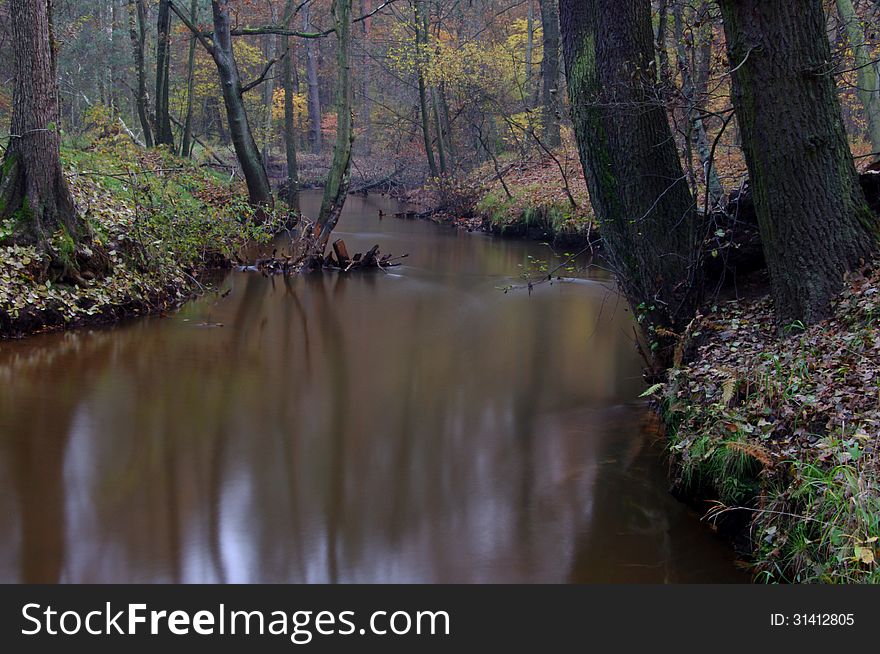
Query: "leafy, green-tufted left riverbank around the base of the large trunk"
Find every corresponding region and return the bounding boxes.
[0,125,273,338]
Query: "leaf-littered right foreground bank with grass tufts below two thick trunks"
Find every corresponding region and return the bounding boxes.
[653,264,880,583]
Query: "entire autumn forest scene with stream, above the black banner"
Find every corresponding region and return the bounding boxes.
[0,0,880,583]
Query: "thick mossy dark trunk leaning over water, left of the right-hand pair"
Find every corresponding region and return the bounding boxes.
[560,0,701,365]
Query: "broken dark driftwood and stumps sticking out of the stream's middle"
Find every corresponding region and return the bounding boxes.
[239,239,409,275]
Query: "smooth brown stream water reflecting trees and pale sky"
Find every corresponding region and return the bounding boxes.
[0,197,746,582]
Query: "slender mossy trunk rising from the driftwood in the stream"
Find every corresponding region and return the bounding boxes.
[317,0,354,248]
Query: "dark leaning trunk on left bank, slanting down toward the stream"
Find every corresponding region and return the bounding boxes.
[211,0,272,206]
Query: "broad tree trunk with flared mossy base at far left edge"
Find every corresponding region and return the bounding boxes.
[0,0,107,282]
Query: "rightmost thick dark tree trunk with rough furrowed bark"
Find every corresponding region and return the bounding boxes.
[719,0,878,324]
